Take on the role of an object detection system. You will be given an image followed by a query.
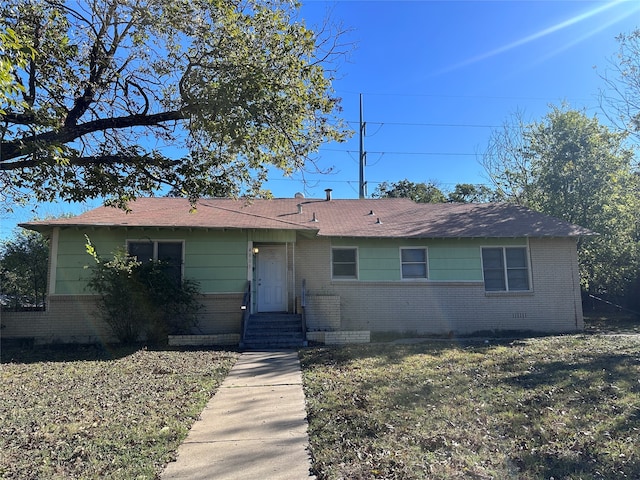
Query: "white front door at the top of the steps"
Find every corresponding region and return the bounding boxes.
[257,245,287,312]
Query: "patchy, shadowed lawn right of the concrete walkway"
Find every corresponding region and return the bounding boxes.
[301,335,640,480]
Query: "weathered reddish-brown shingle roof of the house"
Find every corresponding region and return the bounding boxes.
[21,197,593,238]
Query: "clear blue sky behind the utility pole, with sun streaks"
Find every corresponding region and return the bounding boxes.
[0,0,640,238]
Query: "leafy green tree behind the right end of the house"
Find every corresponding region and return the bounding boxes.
[485,107,640,295]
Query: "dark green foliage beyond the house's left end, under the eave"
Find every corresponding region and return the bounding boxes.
[0,228,49,310]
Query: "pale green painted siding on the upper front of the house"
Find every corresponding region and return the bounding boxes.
[55,227,527,294]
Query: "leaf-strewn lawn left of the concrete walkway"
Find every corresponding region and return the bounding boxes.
[0,347,237,480]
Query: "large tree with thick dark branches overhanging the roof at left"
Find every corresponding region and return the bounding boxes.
[0,0,347,204]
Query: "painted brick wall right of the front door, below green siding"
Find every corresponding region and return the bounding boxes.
[296,238,583,334]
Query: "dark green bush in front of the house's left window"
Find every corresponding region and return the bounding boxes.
[87,238,202,344]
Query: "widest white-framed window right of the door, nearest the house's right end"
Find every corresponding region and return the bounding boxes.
[482,247,529,292]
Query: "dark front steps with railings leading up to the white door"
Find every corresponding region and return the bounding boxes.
[240,313,306,350]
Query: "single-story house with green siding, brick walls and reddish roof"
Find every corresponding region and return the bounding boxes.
[2,195,591,343]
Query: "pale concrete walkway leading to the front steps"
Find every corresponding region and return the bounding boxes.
[161,351,315,480]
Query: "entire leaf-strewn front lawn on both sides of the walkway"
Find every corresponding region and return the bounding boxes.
[0,318,640,480]
